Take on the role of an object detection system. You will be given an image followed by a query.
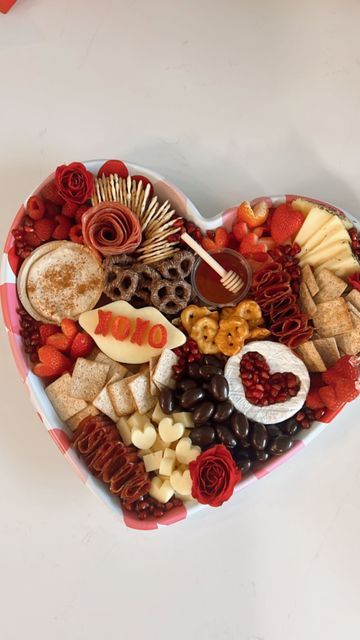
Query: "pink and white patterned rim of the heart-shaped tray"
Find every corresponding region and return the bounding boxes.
[0,160,357,530]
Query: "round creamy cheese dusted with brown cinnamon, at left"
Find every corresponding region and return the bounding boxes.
[18,241,103,324]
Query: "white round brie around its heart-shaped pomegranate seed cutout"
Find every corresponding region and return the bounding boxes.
[225,340,310,424]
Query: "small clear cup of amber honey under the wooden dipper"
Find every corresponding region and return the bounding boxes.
[191,248,252,307]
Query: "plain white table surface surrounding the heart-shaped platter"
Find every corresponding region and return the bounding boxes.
[0,0,360,640]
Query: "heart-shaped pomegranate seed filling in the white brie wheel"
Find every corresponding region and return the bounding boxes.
[240,351,300,407]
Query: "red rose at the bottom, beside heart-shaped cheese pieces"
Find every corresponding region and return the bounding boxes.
[189,444,241,507]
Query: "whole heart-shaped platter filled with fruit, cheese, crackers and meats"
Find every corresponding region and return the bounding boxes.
[1,160,360,530]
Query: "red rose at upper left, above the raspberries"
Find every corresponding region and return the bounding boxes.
[55,162,94,204]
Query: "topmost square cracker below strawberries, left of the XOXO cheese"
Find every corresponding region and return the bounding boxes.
[71,358,109,402]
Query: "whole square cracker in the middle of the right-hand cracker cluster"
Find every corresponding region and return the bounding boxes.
[312,298,352,338]
